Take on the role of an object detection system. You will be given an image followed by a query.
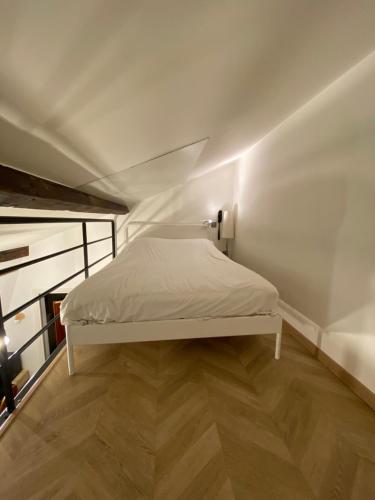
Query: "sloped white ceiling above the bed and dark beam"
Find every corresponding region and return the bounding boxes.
[0,0,375,203]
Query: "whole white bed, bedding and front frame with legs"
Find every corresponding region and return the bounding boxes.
[61,224,282,375]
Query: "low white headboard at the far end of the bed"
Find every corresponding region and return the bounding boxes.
[125,220,215,243]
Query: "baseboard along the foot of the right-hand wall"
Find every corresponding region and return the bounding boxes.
[279,300,375,411]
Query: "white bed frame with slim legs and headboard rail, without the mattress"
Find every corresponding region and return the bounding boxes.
[66,221,282,375]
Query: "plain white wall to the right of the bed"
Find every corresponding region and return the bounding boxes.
[234,53,375,391]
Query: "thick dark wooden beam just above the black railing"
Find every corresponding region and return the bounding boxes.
[0,165,129,214]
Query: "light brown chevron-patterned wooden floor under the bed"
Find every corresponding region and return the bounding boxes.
[0,335,375,500]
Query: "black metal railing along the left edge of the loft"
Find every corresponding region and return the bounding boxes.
[0,217,116,425]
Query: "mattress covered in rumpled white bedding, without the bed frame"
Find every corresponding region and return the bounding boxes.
[61,238,278,325]
